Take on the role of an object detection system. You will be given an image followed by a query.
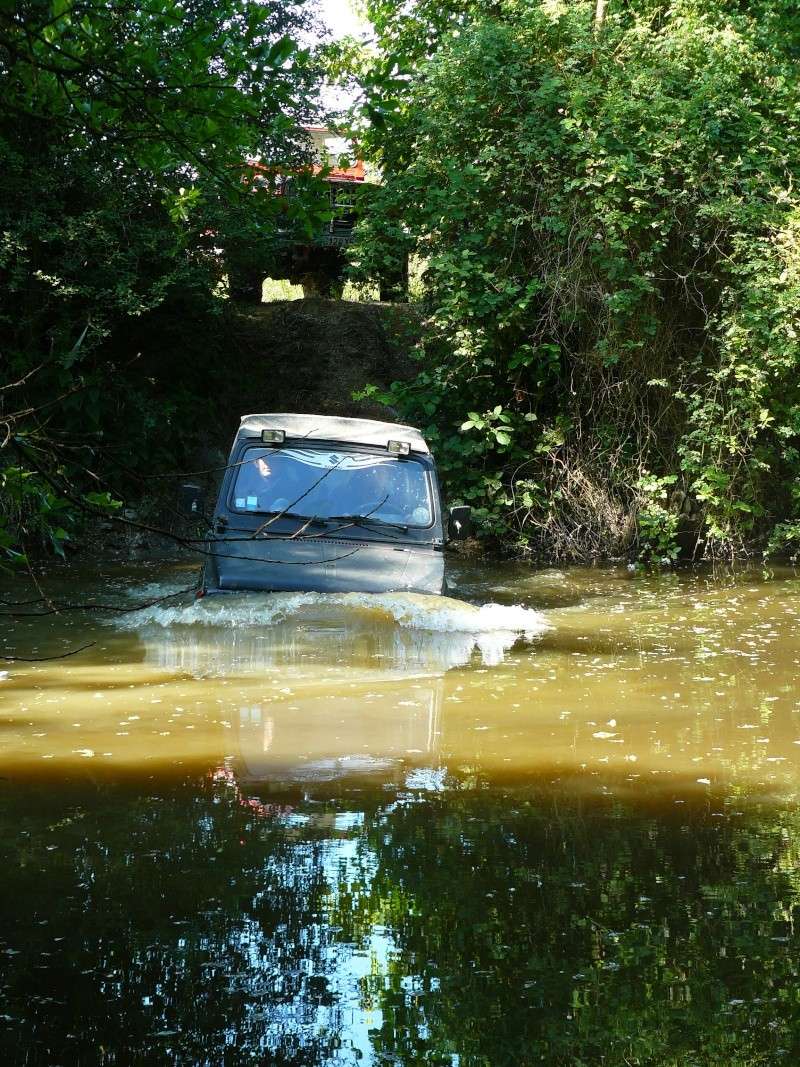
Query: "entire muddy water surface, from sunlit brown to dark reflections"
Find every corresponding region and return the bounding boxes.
[0,564,800,1067]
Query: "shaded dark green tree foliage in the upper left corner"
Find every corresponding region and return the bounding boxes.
[0,0,322,551]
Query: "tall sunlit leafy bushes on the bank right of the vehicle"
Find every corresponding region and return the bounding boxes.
[353,0,800,559]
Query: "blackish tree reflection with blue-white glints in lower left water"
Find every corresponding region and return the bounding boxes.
[0,778,362,1064]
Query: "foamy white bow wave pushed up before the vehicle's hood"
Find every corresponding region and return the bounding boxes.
[110,592,550,675]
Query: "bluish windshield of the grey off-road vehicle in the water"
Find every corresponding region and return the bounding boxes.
[233,447,433,526]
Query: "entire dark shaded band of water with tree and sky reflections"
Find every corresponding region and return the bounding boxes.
[0,774,800,1067]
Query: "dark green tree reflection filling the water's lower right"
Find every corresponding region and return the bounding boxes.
[353,791,800,1067]
